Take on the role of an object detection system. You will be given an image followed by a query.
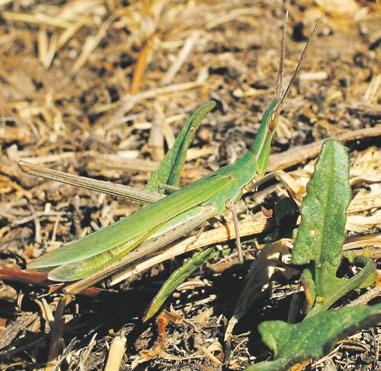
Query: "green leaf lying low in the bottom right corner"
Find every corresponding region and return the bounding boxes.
[246,304,381,371]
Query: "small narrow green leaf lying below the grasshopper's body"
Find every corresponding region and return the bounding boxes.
[143,247,219,322]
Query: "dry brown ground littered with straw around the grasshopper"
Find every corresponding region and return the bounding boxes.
[0,0,381,370]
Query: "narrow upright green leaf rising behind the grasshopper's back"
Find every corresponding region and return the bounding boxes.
[145,101,216,193]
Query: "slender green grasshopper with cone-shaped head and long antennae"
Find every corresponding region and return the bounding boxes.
[19,19,317,293]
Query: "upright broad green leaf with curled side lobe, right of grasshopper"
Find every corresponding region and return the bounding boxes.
[292,139,375,315]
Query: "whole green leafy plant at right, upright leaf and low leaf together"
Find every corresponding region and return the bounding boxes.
[246,139,381,371]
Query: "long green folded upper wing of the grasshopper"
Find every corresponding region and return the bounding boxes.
[29,175,231,269]
